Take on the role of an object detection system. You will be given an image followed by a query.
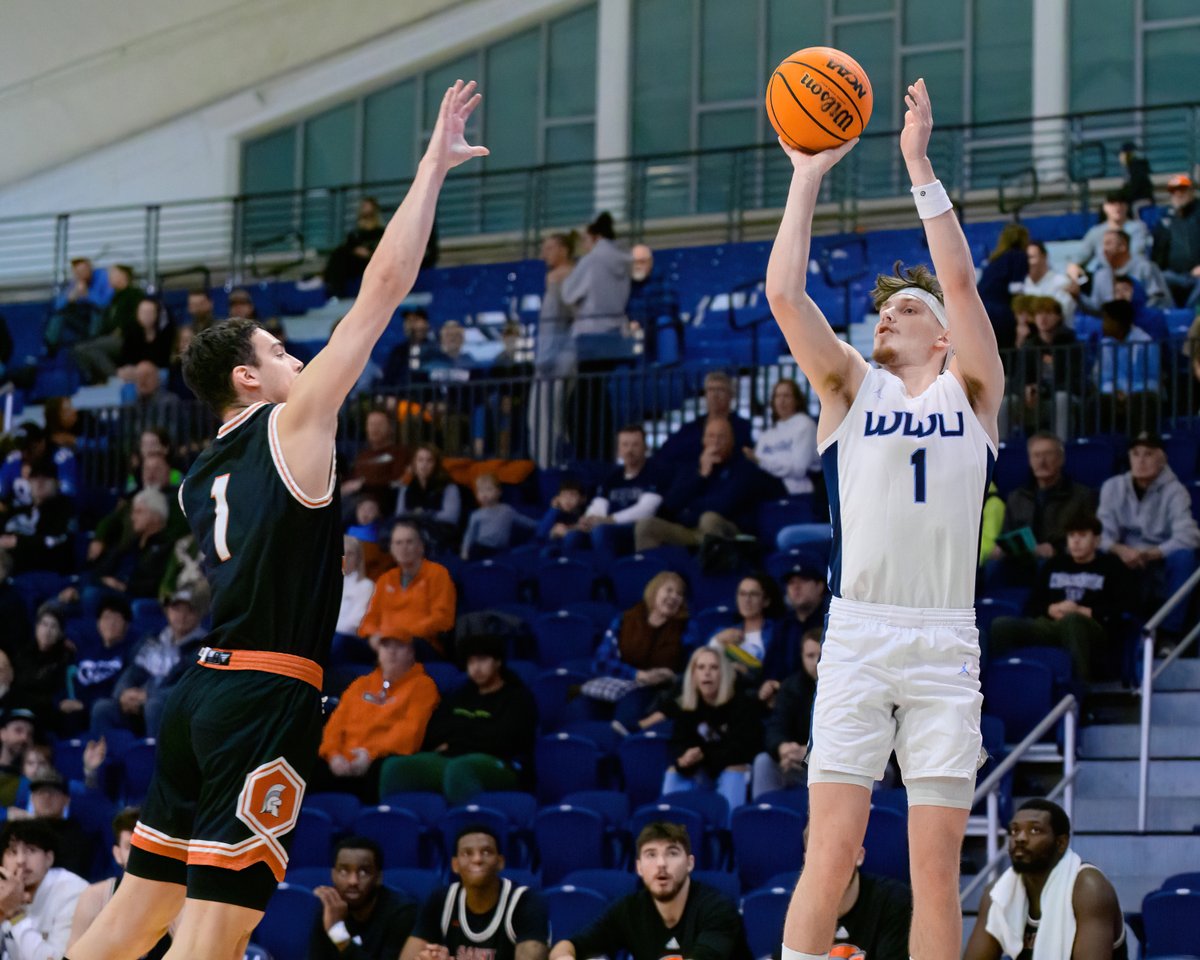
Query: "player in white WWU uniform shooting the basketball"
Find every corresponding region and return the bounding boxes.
[767,80,1004,960]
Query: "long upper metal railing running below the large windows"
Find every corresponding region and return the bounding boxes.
[7,103,1200,296]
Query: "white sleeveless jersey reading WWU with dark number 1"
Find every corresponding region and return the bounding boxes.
[820,366,996,610]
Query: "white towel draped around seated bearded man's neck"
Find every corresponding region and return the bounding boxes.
[986,847,1082,960]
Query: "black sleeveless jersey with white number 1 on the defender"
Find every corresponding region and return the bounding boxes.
[179,403,342,665]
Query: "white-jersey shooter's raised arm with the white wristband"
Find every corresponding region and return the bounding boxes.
[900,80,1004,440]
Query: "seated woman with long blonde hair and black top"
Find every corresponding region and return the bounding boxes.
[662,647,762,811]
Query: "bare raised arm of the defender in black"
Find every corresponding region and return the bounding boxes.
[278,80,487,498]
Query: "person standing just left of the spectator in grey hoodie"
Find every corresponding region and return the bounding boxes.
[529,233,578,467]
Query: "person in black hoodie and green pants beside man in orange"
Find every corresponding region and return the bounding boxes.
[379,635,538,805]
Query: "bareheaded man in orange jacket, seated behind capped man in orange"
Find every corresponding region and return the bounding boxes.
[359,521,456,656]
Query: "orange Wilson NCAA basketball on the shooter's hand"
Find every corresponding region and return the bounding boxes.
[767,47,875,154]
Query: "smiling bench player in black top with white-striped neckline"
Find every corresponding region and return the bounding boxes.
[400,824,550,960]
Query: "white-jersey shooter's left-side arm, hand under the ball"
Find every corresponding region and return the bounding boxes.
[767,139,866,410]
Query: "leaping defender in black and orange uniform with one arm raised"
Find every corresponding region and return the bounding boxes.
[70,80,487,960]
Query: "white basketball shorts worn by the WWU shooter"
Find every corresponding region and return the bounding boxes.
[809,596,984,806]
